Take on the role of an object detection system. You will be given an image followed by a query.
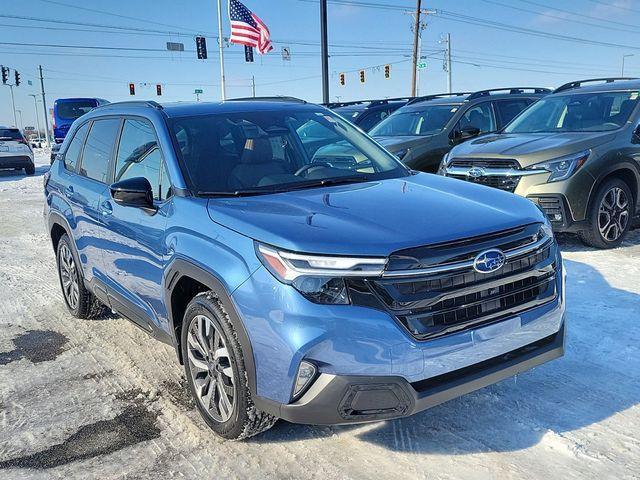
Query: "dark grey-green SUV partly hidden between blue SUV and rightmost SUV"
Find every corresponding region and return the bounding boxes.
[369,87,551,173]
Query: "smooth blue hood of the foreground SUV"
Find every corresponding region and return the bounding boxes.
[208,174,544,257]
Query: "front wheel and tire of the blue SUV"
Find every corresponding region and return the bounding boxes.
[180,292,277,440]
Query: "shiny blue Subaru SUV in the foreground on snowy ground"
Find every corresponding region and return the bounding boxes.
[44,98,565,439]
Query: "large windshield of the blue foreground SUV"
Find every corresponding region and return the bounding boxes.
[170,110,408,195]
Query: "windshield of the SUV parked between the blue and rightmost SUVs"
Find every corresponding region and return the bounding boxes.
[369,105,458,137]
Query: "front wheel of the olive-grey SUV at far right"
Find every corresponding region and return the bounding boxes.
[578,178,634,249]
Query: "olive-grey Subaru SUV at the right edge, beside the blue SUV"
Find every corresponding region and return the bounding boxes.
[440,78,640,248]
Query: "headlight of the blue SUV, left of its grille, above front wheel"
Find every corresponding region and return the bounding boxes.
[256,244,386,305]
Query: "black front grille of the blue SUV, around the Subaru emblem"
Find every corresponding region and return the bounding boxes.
[366,225,557,340]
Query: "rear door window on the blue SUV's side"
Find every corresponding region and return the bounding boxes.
[80,118,120,183]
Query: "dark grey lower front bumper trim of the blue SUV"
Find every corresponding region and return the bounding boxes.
[260,323,565,425]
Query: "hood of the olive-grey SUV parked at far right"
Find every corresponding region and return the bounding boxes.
[451,132,617,166]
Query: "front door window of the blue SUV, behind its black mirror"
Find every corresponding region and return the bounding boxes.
[115,119,171,200]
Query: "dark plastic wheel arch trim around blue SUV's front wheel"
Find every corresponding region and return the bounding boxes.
[163,258,257,402]
